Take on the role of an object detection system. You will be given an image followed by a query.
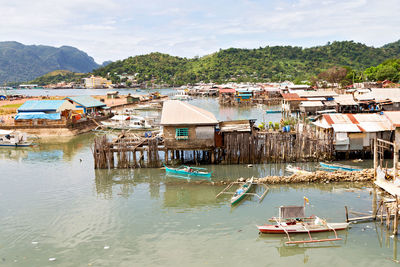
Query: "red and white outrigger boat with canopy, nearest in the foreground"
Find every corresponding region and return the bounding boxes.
[257,203,349,244]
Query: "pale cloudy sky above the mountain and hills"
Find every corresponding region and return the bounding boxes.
[0,0,400,63]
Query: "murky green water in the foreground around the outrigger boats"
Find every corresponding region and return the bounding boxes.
[0,135,398,266]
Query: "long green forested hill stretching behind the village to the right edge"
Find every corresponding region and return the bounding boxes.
[95,41,400,85]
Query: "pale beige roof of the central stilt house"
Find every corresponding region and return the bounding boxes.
[160,100,218,125]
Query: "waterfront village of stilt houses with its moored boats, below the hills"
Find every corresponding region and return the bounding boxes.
[0,81,400,262]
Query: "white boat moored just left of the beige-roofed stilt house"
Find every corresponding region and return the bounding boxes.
[101,115,153,130]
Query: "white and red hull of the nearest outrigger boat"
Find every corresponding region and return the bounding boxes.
[257,223,349,234]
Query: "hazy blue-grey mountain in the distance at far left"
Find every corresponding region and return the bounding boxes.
[0,42,99,83]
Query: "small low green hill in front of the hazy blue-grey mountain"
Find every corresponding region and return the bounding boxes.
[30,70,87,85]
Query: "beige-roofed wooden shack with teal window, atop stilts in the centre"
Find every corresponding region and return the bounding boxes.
[160,100,218,150]
